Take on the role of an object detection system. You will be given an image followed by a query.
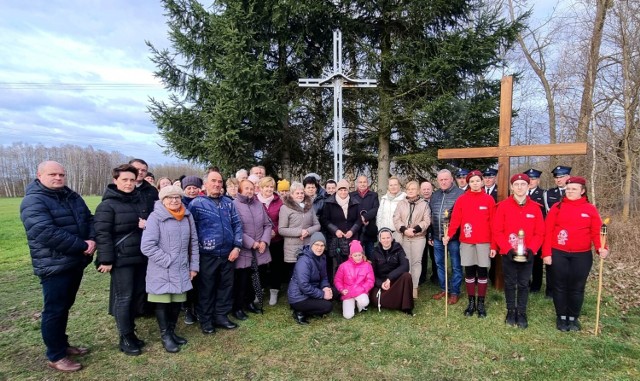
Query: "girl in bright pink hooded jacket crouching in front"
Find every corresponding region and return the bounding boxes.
[334,240,375,319]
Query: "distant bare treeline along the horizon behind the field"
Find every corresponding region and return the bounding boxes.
[0,143,203,197]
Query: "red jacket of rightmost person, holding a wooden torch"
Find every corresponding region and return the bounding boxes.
[542,197,602,258]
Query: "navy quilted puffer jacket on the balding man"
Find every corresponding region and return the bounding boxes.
[20,180,95,277]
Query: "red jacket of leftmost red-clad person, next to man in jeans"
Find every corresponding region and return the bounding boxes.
[448,190,496,244]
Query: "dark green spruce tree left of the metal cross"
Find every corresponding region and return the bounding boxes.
[147,0,335,177]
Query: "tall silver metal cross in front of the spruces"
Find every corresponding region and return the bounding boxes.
[298,30,376,181]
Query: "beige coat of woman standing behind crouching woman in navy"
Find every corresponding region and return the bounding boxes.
[278,196,320,263]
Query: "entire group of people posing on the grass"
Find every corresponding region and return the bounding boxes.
[21,159,608,372]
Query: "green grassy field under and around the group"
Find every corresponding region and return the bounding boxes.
[0,197,640,380]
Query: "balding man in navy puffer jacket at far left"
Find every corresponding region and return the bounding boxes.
[20,161,96,372]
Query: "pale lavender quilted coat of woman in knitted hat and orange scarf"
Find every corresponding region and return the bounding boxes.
[140,201,200,295]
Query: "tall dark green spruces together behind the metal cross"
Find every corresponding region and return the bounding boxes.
[149,0,521,184]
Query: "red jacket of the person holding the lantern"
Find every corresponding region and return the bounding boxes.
[491,196,545,255]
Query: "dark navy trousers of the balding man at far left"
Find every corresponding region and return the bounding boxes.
[40,266,84,361]
